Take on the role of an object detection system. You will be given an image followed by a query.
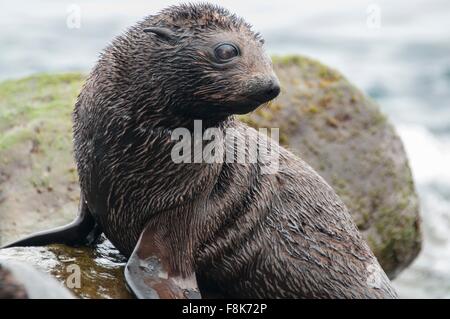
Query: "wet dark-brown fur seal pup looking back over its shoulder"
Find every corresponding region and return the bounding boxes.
[2,4,396,298]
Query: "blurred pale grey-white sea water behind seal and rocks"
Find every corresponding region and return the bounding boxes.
[0,0,450,298]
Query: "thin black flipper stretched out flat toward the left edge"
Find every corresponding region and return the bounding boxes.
[1,197,101,248]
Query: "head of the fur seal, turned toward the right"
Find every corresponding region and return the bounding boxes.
[106,4,280,122]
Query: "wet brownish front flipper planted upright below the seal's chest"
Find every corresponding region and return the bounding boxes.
[125,225,201,299]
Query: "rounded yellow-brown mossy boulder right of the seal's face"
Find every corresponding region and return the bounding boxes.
[240,56,421,278]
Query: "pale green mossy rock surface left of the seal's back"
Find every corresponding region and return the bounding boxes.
[0,73,84,246]
